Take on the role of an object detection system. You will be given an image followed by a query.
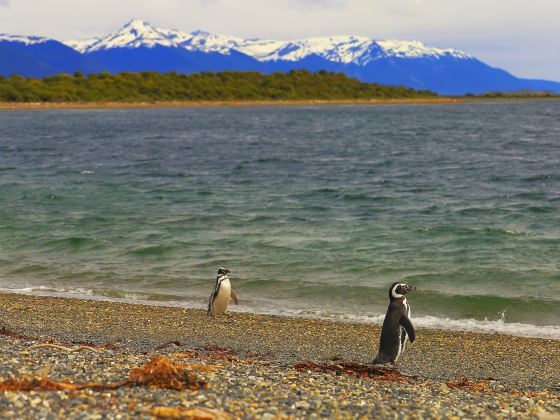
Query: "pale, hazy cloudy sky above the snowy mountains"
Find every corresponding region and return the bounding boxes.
[0,0,560,80]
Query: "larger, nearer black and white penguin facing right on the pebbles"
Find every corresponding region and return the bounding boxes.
[372,282,416,365]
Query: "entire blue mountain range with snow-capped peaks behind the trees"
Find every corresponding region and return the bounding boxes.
[0,20,560,95]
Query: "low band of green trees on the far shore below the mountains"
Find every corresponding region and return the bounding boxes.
[0,70,437,102]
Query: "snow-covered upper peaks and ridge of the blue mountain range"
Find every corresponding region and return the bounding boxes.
[65,20,472,65]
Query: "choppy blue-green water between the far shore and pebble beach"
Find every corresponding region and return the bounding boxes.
[0,101,560,338]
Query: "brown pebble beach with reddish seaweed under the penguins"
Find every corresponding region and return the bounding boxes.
[0,294,560,419]
